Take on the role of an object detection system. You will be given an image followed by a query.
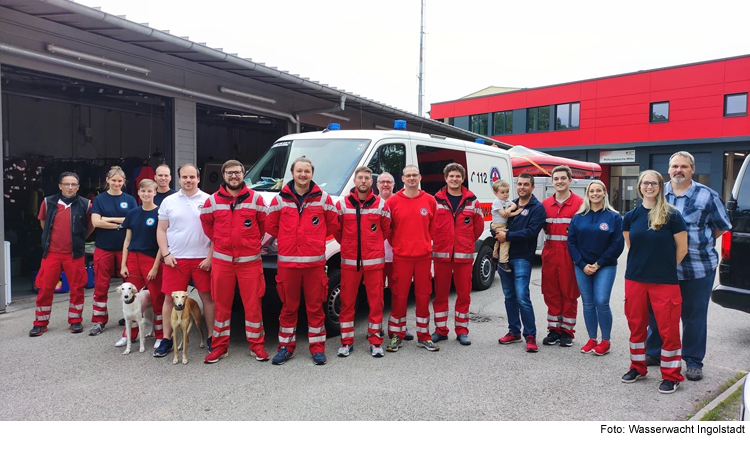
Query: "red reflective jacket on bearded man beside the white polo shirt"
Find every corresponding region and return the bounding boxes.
[201,184,266,262]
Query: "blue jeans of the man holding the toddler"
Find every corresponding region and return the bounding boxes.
[497,259,536,337]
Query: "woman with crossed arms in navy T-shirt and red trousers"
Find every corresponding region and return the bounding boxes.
[89,165,138,338]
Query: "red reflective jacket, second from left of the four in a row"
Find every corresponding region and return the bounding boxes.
[266,181,339,268]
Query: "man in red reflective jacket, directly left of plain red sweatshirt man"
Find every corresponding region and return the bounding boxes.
[335,167,391,357]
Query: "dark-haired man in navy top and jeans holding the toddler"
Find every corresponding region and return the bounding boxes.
[495,173,547,352]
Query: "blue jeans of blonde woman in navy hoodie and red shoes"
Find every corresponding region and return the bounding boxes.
[575,265,617,340]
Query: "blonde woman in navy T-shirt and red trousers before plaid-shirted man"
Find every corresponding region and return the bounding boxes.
[622,170,687,394]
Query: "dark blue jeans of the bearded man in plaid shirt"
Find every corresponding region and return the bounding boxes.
[646,270,716,368]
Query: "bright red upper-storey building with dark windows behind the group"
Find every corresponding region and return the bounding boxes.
[430,55,750,213]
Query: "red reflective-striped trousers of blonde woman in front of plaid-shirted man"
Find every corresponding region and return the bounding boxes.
[625,279,685,382]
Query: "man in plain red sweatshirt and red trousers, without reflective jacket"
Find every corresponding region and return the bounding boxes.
[386,165,440,352]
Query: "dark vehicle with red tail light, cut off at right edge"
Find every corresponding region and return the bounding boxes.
[711,156,750,313]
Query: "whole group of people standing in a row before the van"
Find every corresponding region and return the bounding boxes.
[29,151,730,393]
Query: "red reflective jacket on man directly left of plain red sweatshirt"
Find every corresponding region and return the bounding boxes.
[334,187,391,271]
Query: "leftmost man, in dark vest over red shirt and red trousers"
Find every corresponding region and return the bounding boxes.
[29,172,94,337]
